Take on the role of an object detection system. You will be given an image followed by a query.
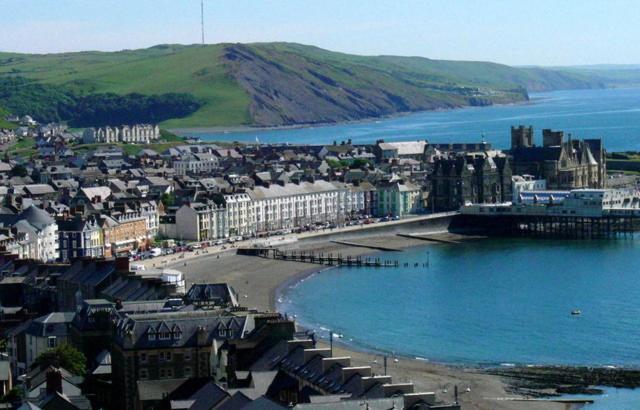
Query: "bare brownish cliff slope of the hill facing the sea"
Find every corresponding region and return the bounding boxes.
[222,45,528,126]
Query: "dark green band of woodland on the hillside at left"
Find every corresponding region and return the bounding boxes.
[0,77,201,127]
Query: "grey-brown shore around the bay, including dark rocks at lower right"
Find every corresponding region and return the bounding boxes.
[152,230,640,410]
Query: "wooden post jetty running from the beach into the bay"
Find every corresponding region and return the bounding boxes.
[236,248,400,268]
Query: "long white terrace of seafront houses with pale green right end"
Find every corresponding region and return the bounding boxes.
[168,180,424,241]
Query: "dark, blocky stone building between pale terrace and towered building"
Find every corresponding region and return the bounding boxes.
[429,151,512,211]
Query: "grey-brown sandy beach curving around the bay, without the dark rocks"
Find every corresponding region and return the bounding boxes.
[145,233,570,409]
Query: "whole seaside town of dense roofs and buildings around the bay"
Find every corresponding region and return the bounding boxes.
[0,116,640,409]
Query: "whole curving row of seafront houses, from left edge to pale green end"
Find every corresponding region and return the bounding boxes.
[0,180,423,261]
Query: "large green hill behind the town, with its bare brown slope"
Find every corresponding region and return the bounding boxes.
[0,43,603,128]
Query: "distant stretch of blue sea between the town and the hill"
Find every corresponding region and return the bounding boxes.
[188,88,640,151]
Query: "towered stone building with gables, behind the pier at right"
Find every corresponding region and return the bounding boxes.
[511,125,607,190]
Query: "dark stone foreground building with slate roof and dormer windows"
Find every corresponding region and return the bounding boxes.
[111,308,280,409]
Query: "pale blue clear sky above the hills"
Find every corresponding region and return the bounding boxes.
[0,0,640,66]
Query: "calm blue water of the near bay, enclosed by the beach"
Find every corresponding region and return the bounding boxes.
[279,238,640,366]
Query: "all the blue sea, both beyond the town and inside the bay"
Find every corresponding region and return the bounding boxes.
[185,89,640,409]
